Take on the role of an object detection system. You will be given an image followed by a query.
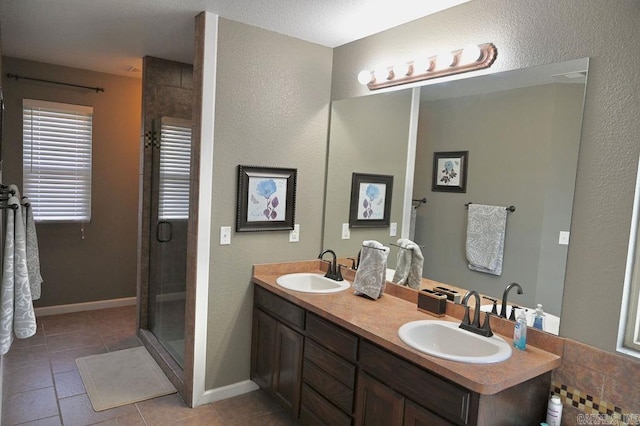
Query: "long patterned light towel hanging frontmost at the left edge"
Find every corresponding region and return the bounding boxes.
[0,197,36,354]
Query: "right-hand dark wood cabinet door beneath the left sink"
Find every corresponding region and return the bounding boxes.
[271,323,304,418]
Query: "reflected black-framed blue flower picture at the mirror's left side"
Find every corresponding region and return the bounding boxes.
[349,173,393,228]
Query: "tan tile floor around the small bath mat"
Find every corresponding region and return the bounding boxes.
[2,306,295,426]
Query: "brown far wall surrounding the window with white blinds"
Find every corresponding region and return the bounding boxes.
[2,57,141,307]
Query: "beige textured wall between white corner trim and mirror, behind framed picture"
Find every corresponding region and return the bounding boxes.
[203,19,332,389]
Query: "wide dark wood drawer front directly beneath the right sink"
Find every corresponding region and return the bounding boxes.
[360,341,477,424]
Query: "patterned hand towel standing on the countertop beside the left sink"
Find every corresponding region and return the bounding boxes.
[353,240,389,300]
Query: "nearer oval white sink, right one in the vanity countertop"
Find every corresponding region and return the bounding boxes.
[398,320,511,364]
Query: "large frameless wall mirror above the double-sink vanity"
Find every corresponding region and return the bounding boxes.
[323,58,588,333]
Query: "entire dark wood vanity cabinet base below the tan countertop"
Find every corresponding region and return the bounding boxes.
[251,286,551,426]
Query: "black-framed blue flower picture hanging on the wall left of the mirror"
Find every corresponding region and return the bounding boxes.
[236,166,297,232]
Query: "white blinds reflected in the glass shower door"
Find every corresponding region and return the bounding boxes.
[158,117,191,220]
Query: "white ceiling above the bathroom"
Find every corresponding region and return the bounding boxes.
[0,0,470,76]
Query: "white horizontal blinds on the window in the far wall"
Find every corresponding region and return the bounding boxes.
[22,99,93,222]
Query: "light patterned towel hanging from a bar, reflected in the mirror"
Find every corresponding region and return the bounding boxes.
[466,204,507,275]
